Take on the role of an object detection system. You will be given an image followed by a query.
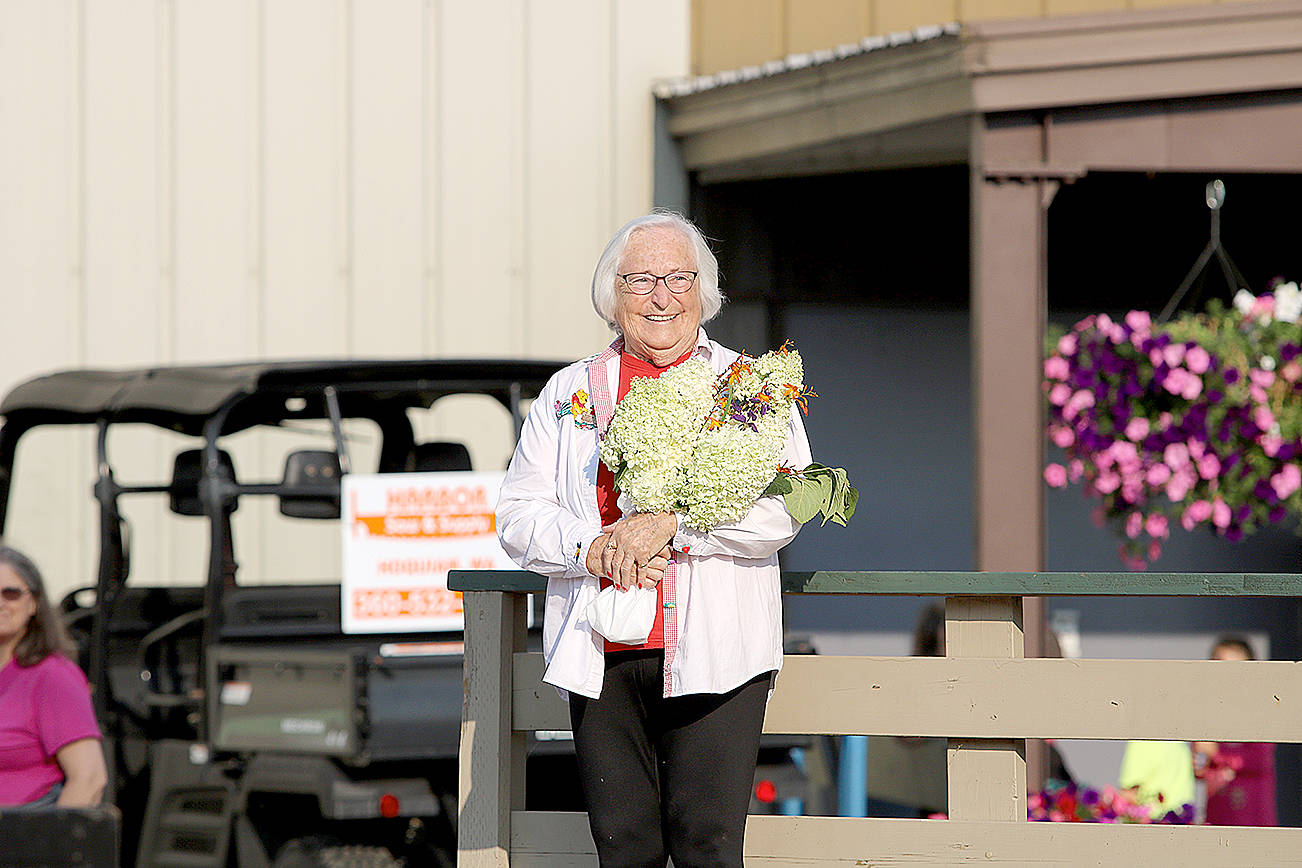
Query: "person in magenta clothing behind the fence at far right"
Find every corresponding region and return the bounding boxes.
[1194,636,1279,826]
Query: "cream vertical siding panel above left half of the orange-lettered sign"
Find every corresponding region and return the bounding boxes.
[350,0,423,357]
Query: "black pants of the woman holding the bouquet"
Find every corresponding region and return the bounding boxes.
[570,651,771,868]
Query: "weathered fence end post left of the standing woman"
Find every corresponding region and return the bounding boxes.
[457,591,529,868]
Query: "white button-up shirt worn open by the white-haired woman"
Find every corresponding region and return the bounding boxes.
[497,329,810,698]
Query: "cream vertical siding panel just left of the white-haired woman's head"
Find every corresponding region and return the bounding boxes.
[526,0,611,358]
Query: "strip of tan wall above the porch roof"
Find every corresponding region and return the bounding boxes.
[691,0,1265,75]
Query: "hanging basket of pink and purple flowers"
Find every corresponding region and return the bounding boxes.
[1044,282,1302,569]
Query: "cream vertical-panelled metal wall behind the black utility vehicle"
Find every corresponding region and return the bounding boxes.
[0,0,690,598]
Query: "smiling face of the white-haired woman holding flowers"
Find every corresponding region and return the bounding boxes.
[615,226,700,367]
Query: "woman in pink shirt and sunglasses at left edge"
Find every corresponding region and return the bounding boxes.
[0,545,108,808]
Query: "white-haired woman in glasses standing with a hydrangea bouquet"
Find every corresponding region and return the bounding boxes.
[497,212,810,868]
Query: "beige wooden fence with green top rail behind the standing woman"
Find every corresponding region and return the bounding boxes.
[449,570,1302,868]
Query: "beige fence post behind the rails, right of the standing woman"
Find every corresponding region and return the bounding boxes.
[945,597,1034,821]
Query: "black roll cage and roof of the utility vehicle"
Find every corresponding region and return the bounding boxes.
[0,359,562,740]
